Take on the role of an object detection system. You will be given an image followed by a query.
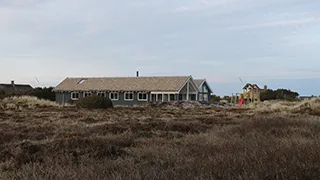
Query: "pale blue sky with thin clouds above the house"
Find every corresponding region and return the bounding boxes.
[0,0,320,95]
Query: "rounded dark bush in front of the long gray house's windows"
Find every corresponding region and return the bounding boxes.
[76,95,113,109]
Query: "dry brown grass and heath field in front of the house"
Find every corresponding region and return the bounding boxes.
[0,97,320,180]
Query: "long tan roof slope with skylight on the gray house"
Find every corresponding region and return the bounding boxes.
[53,76,192,92]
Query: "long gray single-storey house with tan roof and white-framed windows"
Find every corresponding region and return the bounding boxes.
[53,76,212,106]
